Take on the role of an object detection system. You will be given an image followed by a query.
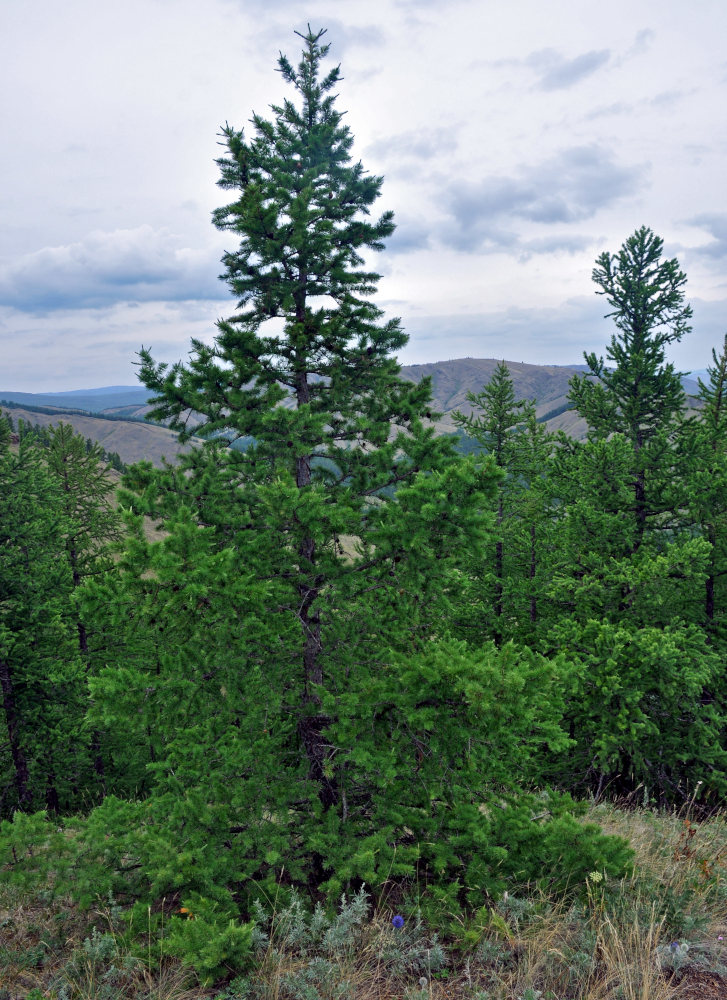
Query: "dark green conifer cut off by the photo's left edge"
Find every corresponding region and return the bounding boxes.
[0,419,86,813]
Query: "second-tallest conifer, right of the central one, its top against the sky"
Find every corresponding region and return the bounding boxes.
[550,227,724,802]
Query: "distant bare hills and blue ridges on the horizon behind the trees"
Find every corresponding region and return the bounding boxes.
[0,358,704,465]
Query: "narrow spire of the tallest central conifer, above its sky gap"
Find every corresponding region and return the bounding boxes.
[208,28,394,322]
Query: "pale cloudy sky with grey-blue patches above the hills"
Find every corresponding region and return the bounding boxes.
[0,0,727,391]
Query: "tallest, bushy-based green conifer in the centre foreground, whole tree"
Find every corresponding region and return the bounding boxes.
[75,29,632,919]
